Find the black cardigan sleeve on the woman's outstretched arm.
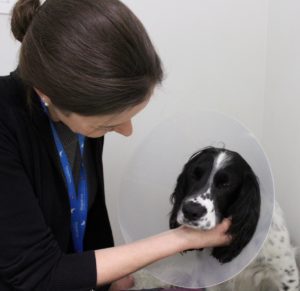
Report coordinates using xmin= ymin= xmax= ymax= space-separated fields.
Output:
xmin=0 ymin=110 xmax=96 ymax=291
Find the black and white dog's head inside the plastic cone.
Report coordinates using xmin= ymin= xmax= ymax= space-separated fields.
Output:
xmin=170 ymin=147 xmax=260 ymax=263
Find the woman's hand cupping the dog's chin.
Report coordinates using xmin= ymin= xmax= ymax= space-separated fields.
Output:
xmin=181 ymin=218 xmax=231 ymax=249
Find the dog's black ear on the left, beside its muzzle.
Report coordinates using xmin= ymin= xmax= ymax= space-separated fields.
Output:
xmin=169 ymin=166 xmax=187 ymax=228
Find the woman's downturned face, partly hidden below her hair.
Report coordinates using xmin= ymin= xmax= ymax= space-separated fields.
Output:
xmin=37 ymin=91 xmax=150 ymax=138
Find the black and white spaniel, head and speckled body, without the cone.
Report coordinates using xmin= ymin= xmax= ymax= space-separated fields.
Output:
xmin=170 ymin=147 xmax=299 ymax=291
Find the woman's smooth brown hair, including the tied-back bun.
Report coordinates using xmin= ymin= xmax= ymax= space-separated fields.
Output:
xmin=11 ymin=0 xmax=163 ymax=116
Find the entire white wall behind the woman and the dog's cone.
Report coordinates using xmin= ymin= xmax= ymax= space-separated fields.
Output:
xmin=0 ymin=0 xmax=300 ymax=244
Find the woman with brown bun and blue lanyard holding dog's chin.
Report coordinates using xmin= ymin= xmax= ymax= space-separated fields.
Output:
xmin=0 ymin=0 xmax=229 ymax=291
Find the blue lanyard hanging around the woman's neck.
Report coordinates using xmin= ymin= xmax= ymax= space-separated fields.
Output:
xmin=41 ymin=102 xmax=88 ymax=253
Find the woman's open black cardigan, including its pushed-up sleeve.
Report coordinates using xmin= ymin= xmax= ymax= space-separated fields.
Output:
xmin=0 ymin=72 xmax=113 ymax=291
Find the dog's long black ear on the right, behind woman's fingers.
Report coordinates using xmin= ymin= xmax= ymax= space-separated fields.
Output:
xmin=212 ymin=168 xmax=260 ymax=263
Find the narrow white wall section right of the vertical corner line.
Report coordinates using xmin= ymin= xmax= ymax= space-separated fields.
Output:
xmin=263 ymin=0 xmax=300 ymax=245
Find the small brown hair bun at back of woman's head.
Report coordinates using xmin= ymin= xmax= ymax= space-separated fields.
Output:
xmin=11 ymin=0 xmax=40 ymax=42
